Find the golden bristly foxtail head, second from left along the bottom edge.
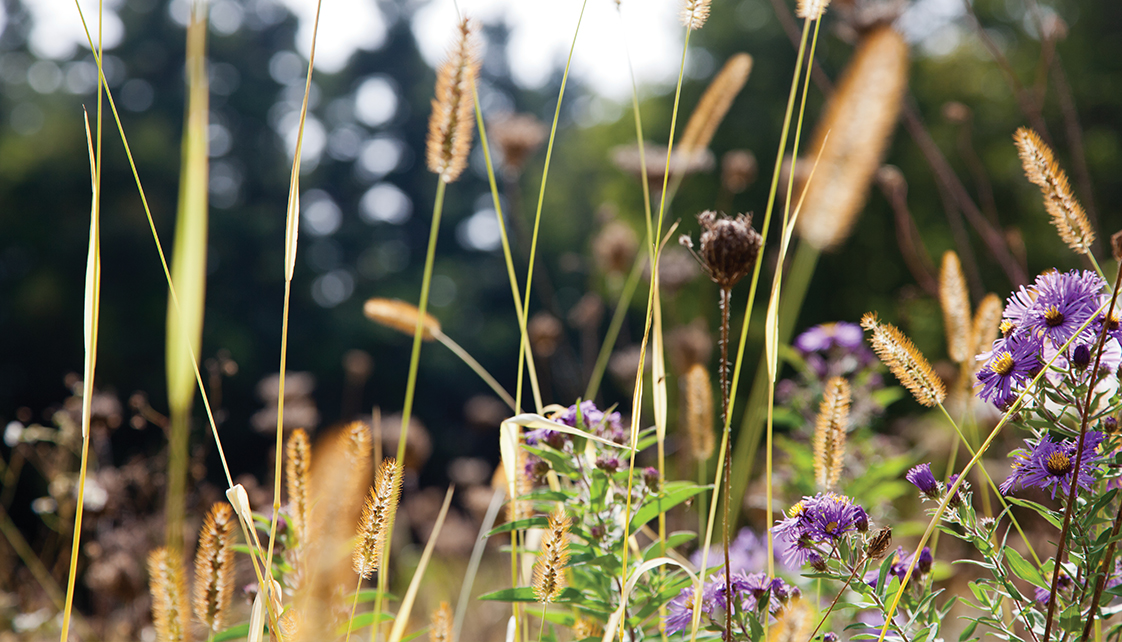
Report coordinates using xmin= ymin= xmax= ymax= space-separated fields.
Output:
xmin=194 ymin=502 xmax=238 ymax=633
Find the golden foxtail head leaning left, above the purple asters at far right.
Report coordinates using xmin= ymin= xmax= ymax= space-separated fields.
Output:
xmin=1013 ymin=127 xmax=1095 ymax=254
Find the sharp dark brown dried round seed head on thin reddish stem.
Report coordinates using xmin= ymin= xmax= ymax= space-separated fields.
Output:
xmin=679 ymin=210 xmax=763 ymax=290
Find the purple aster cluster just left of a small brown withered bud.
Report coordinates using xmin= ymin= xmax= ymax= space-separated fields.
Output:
xmin=772 ymin=493 xmax=868 ymax=568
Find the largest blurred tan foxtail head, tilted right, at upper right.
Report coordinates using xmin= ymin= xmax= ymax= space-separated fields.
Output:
xmin=794 ymin=26 xmax=908 ymax=250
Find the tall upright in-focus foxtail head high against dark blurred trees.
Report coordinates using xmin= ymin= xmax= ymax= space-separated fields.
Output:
xmin=426 ymin=18 xmax=479 ymax=183
